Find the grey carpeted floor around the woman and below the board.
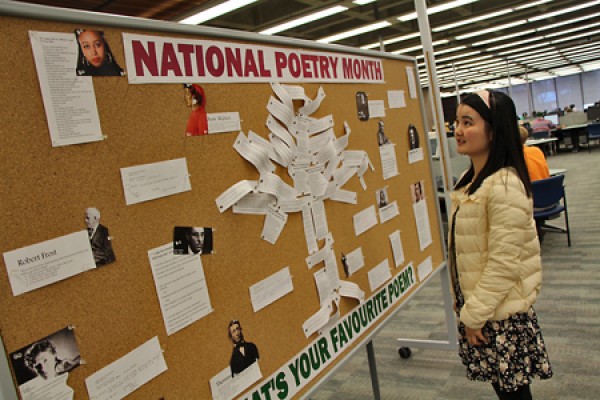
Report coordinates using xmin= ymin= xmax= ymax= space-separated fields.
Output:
xmin=310 ymin=146 xmax=600 ymax=400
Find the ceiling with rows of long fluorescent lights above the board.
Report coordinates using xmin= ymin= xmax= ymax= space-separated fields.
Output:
xmin=11 ymin=0 xmax=600 ymax=91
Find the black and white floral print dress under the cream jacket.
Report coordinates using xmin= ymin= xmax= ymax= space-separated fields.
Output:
xmin=449 ymin=209 xmax=552 ymax=392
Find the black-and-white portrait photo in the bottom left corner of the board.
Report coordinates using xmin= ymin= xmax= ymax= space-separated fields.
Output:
xmin=10 ymin=326 xmax=81 ymax=386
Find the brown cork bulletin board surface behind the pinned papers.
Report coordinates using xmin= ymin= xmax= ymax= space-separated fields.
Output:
xmin=0 ymin=3 xmax=444 ymax=400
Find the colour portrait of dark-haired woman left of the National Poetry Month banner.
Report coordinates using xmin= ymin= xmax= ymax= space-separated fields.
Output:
xmin=75 ymin=29 xmax=125 ymax=76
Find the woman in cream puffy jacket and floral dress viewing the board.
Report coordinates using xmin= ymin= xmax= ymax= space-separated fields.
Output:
xmin=448 ymin=91 xmax=552 ymax=399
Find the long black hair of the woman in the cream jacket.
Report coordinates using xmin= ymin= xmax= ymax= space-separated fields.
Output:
xmin=455 ymin=91 xmax=531 ymax=197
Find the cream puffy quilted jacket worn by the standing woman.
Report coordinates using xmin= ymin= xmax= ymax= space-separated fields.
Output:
xmin=449 ymin=168 xmax=542 ymax=329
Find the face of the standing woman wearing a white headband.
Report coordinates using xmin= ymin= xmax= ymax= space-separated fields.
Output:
xmin=454 ymin=104 xmax=492 ymax=157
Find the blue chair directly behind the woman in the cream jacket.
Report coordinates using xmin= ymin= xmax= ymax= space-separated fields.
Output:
xmin=532 ymin=175 xmax=571 ymax=247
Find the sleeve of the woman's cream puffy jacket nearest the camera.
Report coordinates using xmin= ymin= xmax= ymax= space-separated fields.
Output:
xmin=460 ymin=171 xmax=532 ymax=329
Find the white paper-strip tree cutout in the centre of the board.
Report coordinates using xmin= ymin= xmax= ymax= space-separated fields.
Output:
xmin=216 ymin=83 xmax=373 ymax=336
